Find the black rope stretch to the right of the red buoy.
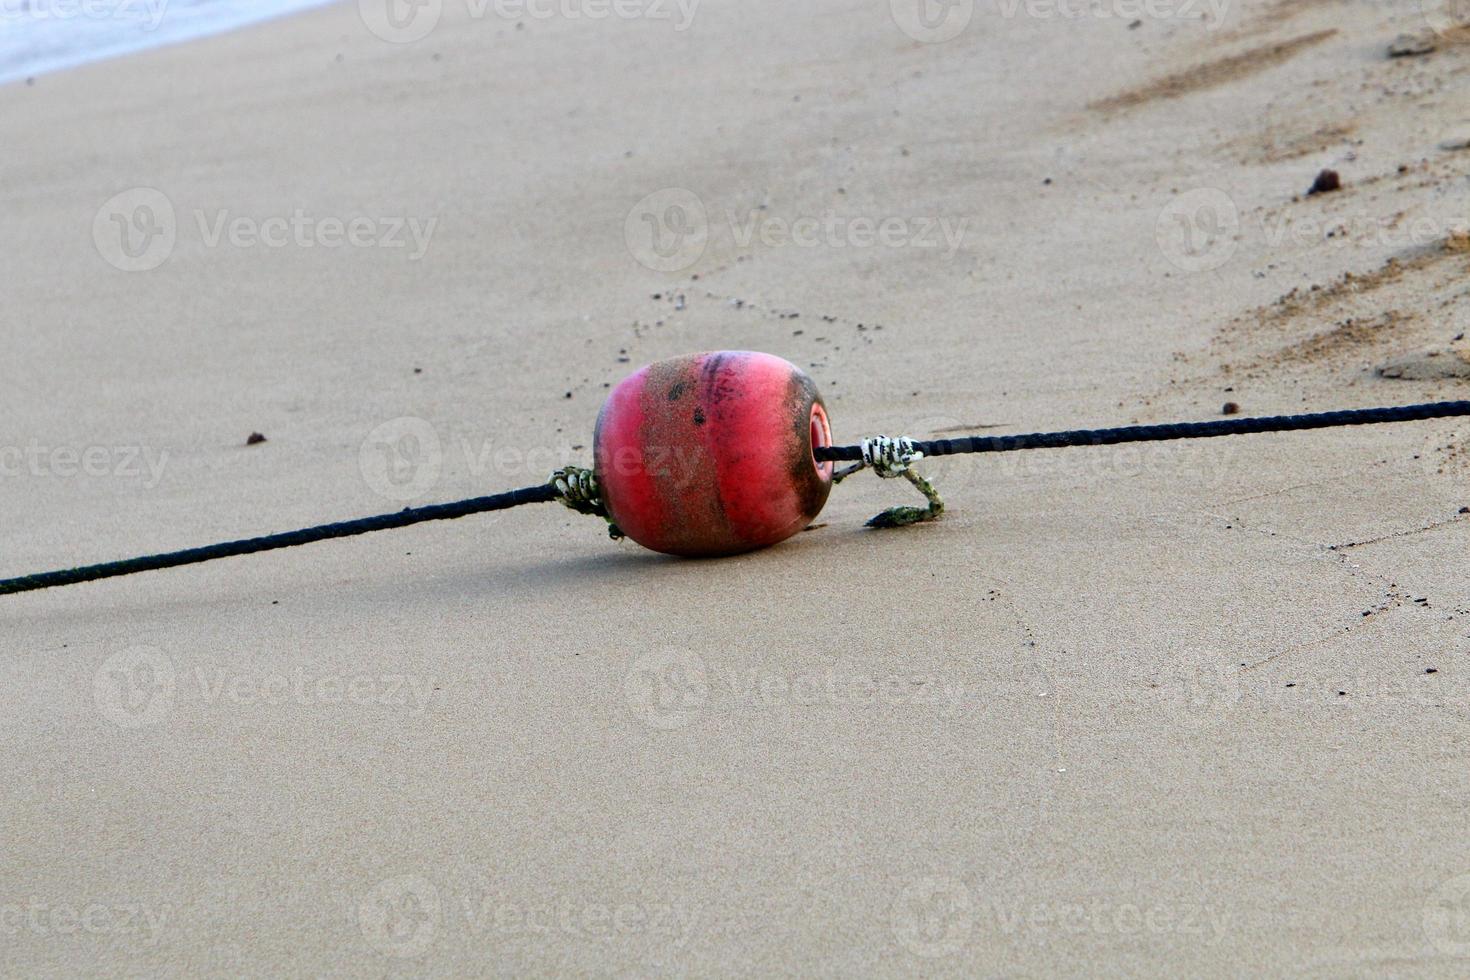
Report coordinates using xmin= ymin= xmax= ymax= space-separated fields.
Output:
xmin=816 ymin=401 xmax=1470 ymax=461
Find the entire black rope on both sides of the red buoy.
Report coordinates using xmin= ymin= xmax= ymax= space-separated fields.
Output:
xmin=0 ymin=401 xmax=1470 ymax=595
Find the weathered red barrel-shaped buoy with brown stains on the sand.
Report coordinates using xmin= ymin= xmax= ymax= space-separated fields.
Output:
xmin=592 ymin=351 xmax=832 ymax=557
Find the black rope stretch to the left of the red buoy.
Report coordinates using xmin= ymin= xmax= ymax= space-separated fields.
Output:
xmin=0 ymin=483 xmax=557 ymax=595
